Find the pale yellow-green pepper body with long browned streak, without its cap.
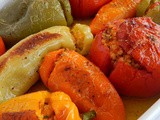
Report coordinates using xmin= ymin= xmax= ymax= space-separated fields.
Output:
xmin=0 ymin=26 xmax=75 ymax=102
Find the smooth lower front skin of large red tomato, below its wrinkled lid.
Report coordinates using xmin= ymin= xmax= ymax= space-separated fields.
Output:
xmin=109 ymin=61 xmax=160 ymax=97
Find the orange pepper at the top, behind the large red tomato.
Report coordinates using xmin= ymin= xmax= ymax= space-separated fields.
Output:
xmin=90 ymin=0 xmax=141 ymax=35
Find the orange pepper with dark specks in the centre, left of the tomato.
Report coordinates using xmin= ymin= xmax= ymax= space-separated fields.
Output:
xmin=39 ymin=49 xmax=125 ymax=120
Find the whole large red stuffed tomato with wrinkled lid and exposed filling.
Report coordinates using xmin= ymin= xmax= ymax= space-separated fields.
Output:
xmin=90 ymin=17 xmax=160 ymax=97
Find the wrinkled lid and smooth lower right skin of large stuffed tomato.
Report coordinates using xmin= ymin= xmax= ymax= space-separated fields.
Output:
xmin=109 ymin=17 xmax=160 ymax=97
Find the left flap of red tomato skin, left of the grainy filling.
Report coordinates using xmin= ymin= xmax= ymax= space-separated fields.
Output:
xmin=89 ymin=31 xmax=112 ymax=75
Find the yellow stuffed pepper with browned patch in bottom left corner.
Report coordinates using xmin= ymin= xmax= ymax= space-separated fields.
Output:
xmin=0 ymin=91 xmax=81 ymax=120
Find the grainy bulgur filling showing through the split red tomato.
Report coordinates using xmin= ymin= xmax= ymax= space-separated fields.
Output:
xmin=102 ymin=27 xmax=142 ymax=69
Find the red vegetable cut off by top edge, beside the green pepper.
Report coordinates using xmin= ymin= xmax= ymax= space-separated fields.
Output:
xmin=70 ymin=0 xmax=111 ymax=18
